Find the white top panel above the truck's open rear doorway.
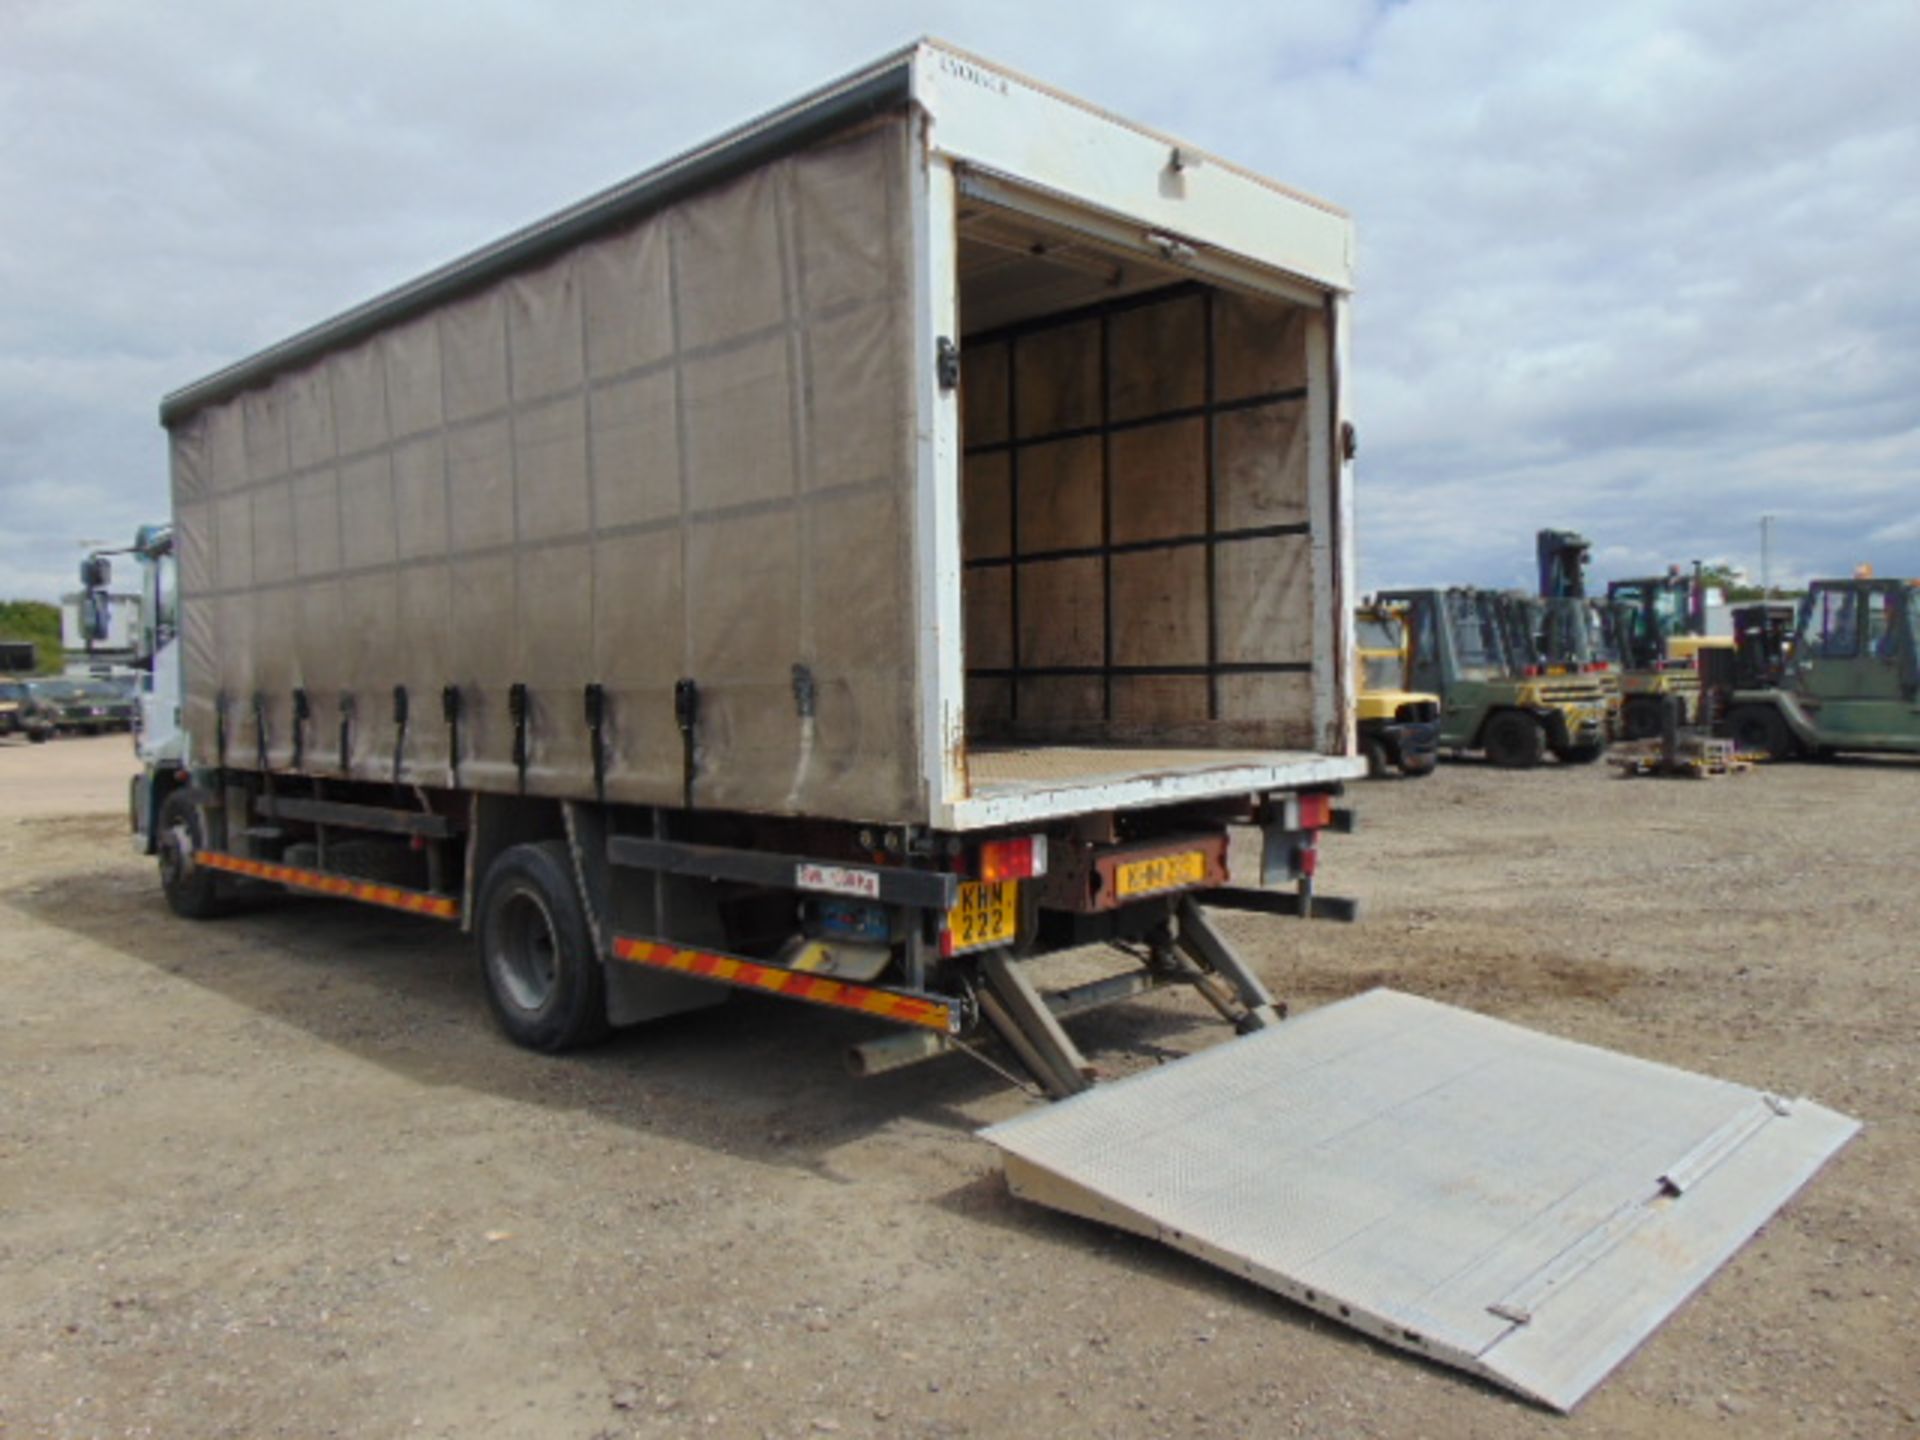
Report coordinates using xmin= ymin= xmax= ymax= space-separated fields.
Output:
xmin=912 ymin=40 xmax=1354 ymax=292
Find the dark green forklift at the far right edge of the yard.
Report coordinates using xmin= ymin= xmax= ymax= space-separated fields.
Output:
xmin=1726 ymin=578 xmax=1920 ymax=760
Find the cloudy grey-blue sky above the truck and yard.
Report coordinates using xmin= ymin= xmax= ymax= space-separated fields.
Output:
xmin=0 ymin=0 xmax=1920 ymax=599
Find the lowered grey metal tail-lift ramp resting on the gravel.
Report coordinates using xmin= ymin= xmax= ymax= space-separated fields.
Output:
xmin=983 ymin=991 xmax=1859 ymax=1409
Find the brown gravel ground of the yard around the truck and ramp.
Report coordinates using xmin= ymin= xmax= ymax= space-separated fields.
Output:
xmin=0 ymin=737 xmax=1920 ymax=1440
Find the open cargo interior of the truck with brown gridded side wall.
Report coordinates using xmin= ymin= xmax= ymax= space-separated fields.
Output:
xmin=956 ymin=194 xmax=1338 ymax=814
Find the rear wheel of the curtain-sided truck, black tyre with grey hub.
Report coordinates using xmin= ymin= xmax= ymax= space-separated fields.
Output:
xmin=474 ymin=841 xmax=609 ymax=1054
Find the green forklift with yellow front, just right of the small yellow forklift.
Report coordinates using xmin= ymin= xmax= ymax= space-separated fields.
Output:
xmin=1377 ymin=586 xmax=1607 ymax=770
